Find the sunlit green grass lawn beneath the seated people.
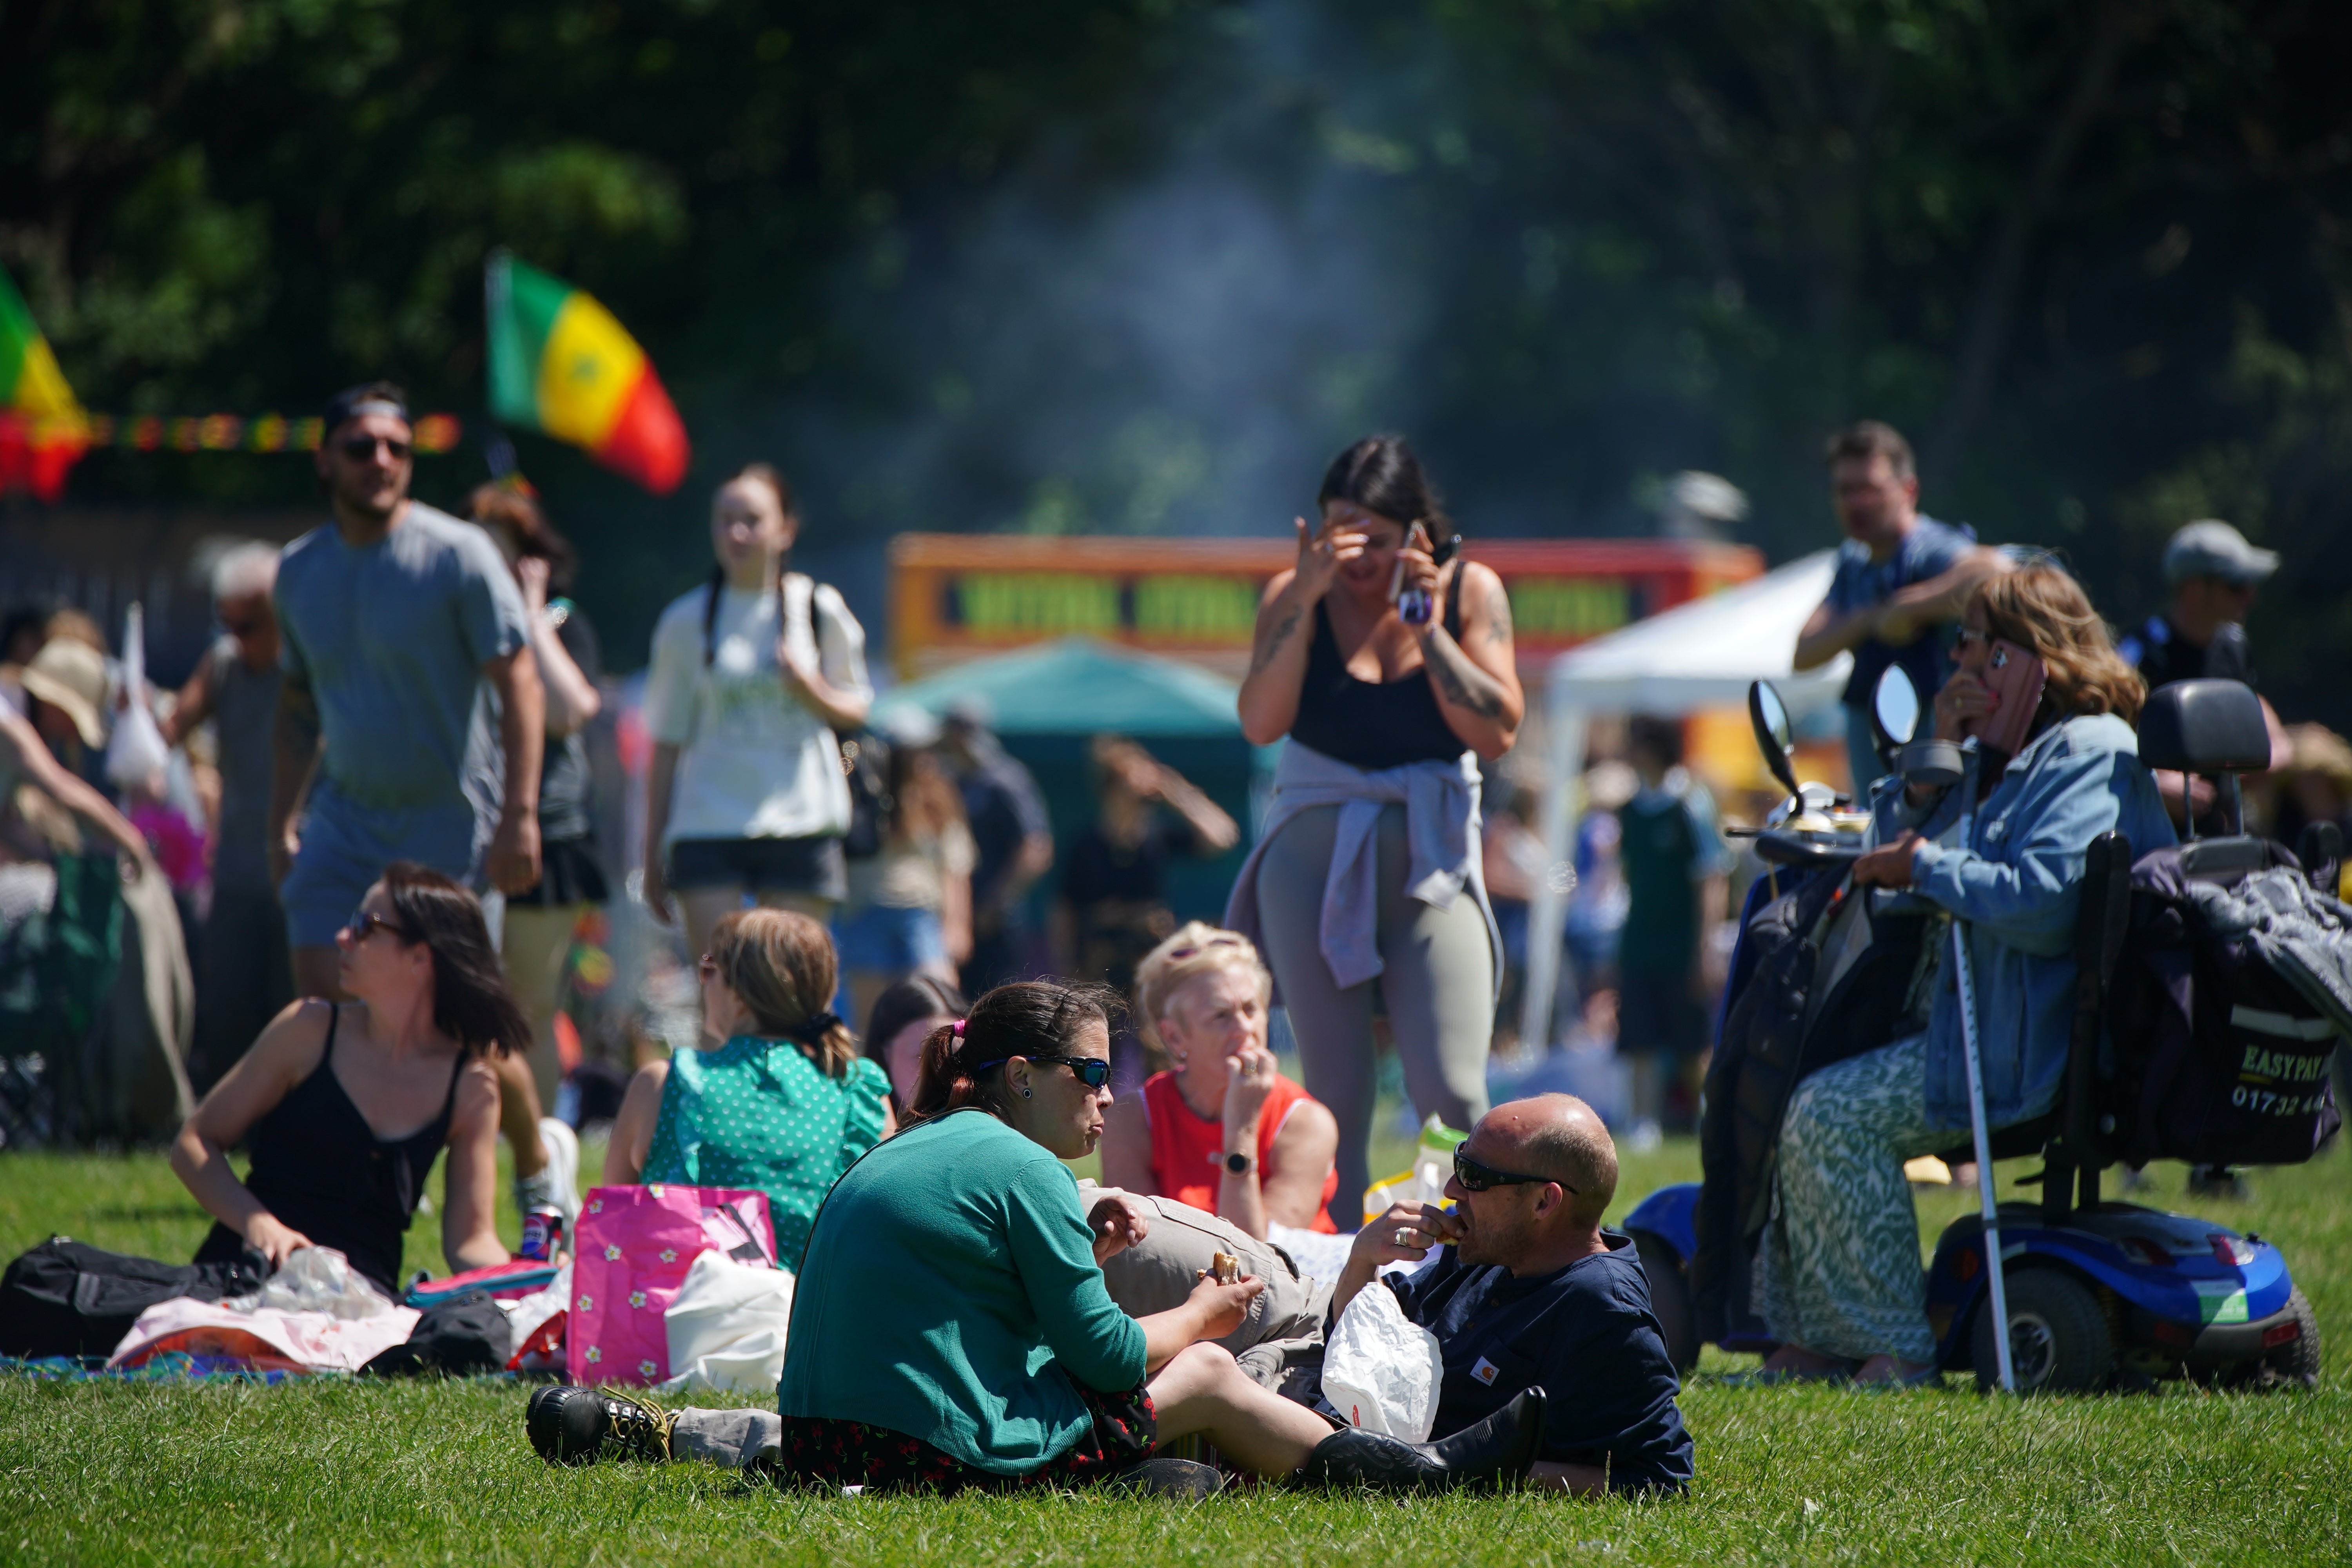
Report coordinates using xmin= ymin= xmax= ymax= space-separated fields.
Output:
xmin=0 ymin=1143 xmax=2352 ymax=1568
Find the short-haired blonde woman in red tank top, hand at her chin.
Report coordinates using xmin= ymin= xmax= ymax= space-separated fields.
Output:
xmin=1101 ymin=919 xmax=1338 ymax=1241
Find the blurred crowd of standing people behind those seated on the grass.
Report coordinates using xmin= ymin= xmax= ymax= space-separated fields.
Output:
xmin=0 ymin=386 xmax=2324 ymax=1189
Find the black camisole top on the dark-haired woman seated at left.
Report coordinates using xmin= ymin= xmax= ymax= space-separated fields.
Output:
xmin=195 ymin=1004 xmax=466 ymax=1300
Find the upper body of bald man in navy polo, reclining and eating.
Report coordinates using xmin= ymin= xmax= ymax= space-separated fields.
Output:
xmin=1331 ymin=1096 xmax=1691 ymax=1493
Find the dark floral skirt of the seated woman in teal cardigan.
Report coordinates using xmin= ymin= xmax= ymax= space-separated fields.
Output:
xmin=781 ymin=1380 xmax=1160 ymax=1493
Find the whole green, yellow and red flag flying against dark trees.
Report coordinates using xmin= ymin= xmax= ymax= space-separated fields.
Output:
xmin=485 ymin=249 xmax=687 ymax=496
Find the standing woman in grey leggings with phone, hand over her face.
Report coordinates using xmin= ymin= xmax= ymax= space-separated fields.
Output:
xmin=1225 ymin=435 xmax=1524 ymax=1232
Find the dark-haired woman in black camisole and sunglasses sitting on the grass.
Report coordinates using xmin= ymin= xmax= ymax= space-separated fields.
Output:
xmin=172 ymin=860 xmax=532 ymax=1295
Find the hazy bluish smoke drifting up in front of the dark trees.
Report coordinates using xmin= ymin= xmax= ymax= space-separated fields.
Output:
xmin=786 ymin=2 xmax=1430 ymax=557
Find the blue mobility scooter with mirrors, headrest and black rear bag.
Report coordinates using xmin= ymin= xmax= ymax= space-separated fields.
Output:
xmin=1623 ymin=670 xmax=2345 ymax=1392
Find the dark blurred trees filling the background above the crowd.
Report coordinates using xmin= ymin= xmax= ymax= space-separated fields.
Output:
xmin=0 ymin=0 xmax=2352 ymax=726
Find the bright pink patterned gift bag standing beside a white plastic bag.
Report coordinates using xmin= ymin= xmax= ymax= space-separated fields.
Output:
xmin=564 ymin=1182 xmax=776 ymax=1385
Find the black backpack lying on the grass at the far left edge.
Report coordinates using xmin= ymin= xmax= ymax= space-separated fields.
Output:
xmin=0 ymin=1236 xmax=268 ymax=1359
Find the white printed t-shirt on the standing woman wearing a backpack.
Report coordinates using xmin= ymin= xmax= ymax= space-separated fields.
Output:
xmin=644 ymin=571 xmax=870 ymax=846
